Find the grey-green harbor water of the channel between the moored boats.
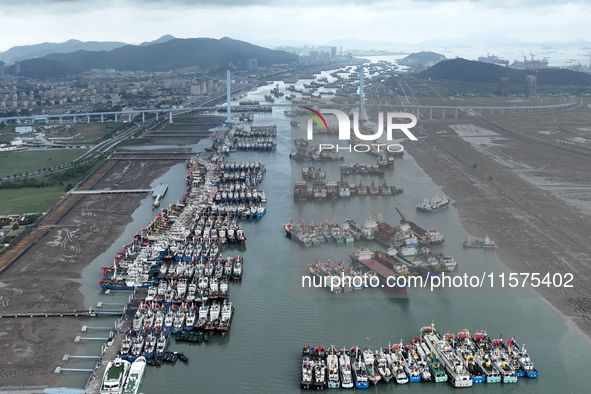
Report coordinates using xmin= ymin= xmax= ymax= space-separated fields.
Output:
xmin=65 ymin=73 xmax=591 ymax=394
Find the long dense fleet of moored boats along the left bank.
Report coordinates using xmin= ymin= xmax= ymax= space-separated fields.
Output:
xmin=99 ymin=139 xmax=266 ymax=388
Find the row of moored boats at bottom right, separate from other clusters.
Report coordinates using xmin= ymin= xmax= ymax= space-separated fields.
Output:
xmin=300 ymin=324 xmax=539 ymax=390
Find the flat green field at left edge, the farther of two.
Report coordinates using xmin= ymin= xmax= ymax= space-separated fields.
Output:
xmin=0 ymin=149 xmax=86 ymax=178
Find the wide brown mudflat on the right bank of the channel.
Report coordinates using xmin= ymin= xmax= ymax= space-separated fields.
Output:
xmin=405 ymin=120 xmax=591 ymax=335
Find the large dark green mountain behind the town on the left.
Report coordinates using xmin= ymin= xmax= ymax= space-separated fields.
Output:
xmin=7 ymin=37 xmax=298 ymax=78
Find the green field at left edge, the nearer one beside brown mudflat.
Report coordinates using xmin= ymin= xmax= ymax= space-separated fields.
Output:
xmin=0 ymin=182 xmax=69 ymax=215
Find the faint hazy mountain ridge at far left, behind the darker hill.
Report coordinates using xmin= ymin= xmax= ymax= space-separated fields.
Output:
xmin=0 ymin=40 xmax=127 ymax=63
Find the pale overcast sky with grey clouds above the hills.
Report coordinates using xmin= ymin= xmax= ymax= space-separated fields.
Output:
xmin=0 ymin=0 xmax=591 ymax=51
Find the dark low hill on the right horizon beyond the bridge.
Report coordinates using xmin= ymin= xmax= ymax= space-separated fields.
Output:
xmin=416 ymin=59 xmax=591 ymax=85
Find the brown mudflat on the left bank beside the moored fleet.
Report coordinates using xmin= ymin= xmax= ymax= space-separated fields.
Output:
xmin=0 ymin=159 xmax=184 ymax=387
